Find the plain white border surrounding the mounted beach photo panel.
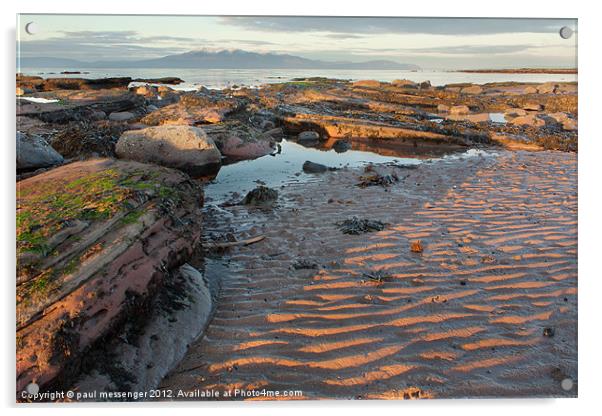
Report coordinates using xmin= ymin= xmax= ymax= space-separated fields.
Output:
xmin=0 ymin=0 xmax=602 ymax=416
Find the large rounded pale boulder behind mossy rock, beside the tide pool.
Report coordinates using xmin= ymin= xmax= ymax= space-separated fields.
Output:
xmin=115 ymin=126 xmax=221 ymax=176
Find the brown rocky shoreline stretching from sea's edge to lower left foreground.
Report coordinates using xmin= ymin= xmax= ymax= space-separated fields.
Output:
xmin=16 ymin=74 xmax=578 ymax=396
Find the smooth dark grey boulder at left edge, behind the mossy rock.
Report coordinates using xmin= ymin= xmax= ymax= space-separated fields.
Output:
xmin=17 ymin=132 xmax=64 ymax=171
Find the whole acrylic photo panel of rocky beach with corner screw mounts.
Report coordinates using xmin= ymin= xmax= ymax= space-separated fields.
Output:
xmin=16 ymin=14 xmax=578 ymax=402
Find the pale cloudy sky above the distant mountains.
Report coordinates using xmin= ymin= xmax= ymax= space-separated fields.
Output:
xmin=17 ymin=15 xmax=577 ymax=69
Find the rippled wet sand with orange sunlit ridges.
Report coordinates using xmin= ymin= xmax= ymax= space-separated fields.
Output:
xmin=161 ymin=151 xmax=577 ymax=400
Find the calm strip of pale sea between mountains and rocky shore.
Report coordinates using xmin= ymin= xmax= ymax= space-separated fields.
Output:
xmin=21 ymin=68 xmax=577 ymax=90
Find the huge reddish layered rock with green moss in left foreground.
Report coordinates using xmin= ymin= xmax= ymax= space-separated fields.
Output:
xmin=16 ymin=159 xmax=202 ymax=391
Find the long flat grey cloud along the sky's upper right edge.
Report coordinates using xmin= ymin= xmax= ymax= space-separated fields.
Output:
xmin=220 ymin=16 xmax=576 ymax=35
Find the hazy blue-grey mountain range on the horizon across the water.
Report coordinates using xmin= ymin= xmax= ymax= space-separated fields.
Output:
xmin=20 ymin=50 xmax=420 ymax=70
